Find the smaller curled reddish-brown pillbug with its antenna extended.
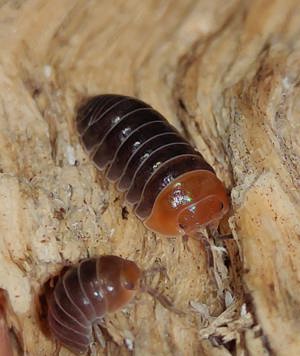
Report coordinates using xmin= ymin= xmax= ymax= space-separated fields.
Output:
xmin=47 ymin=255 xmax=176 ymax=354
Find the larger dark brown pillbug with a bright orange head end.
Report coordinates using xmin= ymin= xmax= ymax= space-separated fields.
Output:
xmin=76 ymin=94 xmax=229 ymax=236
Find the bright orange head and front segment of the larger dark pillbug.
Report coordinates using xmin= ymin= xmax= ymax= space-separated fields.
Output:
xmin=144 ymin=170 xmax=229 ymax=236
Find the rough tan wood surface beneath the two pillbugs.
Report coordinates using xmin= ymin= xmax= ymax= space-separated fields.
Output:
xmin=0 ymin=0 xmax=300 ymax=356
